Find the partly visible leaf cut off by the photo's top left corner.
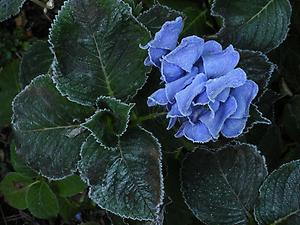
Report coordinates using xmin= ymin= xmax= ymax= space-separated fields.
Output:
xmin=0 ymin=0 xmax=26 ymax=22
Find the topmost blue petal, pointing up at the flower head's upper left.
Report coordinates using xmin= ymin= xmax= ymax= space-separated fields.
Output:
xmin=144 ymin=17 xmax=183 ymax=50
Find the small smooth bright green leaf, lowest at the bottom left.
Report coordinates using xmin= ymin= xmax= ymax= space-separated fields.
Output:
xmin=26 ymin=181 xmax=59 ymax=219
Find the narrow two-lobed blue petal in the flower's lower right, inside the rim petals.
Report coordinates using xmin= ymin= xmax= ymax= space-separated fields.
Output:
xmin=200 ymin=96 xmax=237 ymax=139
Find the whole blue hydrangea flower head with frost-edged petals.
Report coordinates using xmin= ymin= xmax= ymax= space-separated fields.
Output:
xmin=145 ymin=17 xmax=258 ymax=143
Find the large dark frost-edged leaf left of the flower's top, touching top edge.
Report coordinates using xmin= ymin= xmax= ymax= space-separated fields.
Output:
xmin=50 ymin=0 xmax=150 ymax=105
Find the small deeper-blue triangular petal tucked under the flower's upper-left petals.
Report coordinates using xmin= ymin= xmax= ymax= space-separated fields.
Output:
xmin=161 ymin=60 xmax=185 ymax=83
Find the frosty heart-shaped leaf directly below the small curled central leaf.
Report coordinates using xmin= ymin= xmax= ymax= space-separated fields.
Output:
xmin=78 ymin=128 xmax=164 ymax=220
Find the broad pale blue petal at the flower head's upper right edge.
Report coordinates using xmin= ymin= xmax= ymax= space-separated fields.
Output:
xmin=202 ymin=45 xmax=240 ymax=78
